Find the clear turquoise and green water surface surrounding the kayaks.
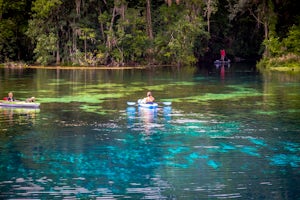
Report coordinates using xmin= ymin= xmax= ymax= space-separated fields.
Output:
xmin=0 ymin=65 xmax=300 ymax=199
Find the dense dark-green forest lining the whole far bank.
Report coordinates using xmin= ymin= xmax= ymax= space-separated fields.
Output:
xmin=0 ymin=0 xmax=300 ymax=66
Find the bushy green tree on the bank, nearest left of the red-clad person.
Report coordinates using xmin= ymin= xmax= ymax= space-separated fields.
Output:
xmin=155 ymin=5 xmax=206 ymax=64
